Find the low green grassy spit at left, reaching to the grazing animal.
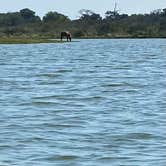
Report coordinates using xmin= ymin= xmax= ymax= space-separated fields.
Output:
xmin=0 ymin=38 xmax=65 ymax=44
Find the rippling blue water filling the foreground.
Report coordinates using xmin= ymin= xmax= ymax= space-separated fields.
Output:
xmin=0 ymin=39 xmax=166 ymax=166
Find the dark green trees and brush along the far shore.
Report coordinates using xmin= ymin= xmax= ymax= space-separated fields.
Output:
xmin=0 ymin=9 xmax=166 ymax=38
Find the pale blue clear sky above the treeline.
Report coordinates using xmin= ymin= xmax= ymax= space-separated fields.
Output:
xmin=0 ymin=0 xmax=166 ymax=19
